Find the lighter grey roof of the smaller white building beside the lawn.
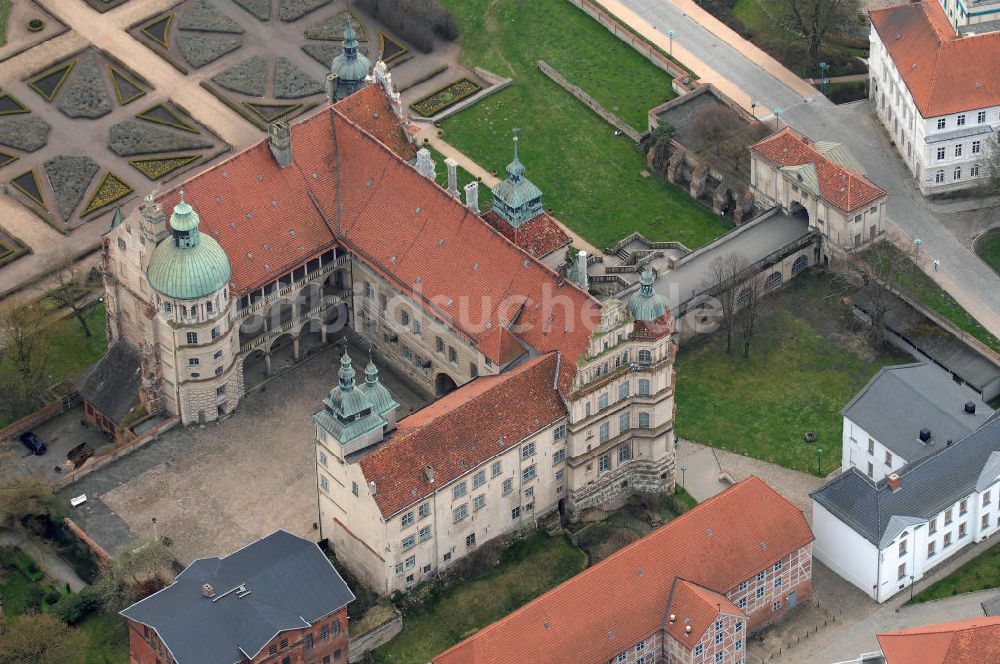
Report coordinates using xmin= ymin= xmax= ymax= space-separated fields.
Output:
xmin=841 ymin=363 xmax=993 ymax=462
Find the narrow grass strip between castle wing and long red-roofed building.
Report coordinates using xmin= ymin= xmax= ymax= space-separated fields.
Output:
xmin=372 ymin=533 xmax=586 ymax=664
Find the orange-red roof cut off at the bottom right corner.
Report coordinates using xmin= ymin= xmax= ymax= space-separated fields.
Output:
xmin=878 ymin=617 xmax=1000 ymax=664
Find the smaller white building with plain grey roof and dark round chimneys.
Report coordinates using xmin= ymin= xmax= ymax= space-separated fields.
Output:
xmin=840 ymin=363 xmax=993 ymax=482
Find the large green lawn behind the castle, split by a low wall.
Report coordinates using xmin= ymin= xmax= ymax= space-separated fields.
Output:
xmin=442 ymin=0 xmax=729 ymax=248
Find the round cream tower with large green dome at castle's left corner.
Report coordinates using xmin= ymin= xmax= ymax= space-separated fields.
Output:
xmin=146 ymin=191 xmax=243 ymax=424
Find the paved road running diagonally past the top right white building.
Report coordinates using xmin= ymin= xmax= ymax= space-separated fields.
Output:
xmin=620 ymin=0 xmax=1000 ymax=335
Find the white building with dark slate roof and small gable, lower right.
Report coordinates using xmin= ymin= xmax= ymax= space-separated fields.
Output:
xmin=812 ymin=419 xmax=1000 ymax=602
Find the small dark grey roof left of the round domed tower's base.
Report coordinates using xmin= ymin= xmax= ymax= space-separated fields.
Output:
xmin=80 ymin=338 xmax=142 ymax=424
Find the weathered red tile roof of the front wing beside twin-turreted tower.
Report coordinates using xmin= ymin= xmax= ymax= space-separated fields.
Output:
xmin=359 ymin=353 xmax=566 ymax=518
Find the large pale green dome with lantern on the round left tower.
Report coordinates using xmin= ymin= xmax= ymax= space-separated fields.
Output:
xmin=146 ymin=193 xmax=232 ymax=300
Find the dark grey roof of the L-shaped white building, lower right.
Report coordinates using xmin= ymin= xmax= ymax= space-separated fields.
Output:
xmin=810 ymin=420 xmax=1000 ymax=549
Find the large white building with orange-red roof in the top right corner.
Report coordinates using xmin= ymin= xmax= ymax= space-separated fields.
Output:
xmin=869 ymin=0 xmax=1000 ymax=194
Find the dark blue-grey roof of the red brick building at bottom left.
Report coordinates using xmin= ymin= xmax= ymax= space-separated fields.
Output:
xmin=121 ymin=530 xmax=354 ymax=664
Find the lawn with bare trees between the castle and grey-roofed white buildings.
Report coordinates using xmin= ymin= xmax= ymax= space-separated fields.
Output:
xmin=677 ymin=273 xmax=912 ymax=475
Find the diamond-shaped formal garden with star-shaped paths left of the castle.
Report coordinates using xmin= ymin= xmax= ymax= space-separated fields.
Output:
xmin=0 ymin=47 xmax=229 ymax=231
